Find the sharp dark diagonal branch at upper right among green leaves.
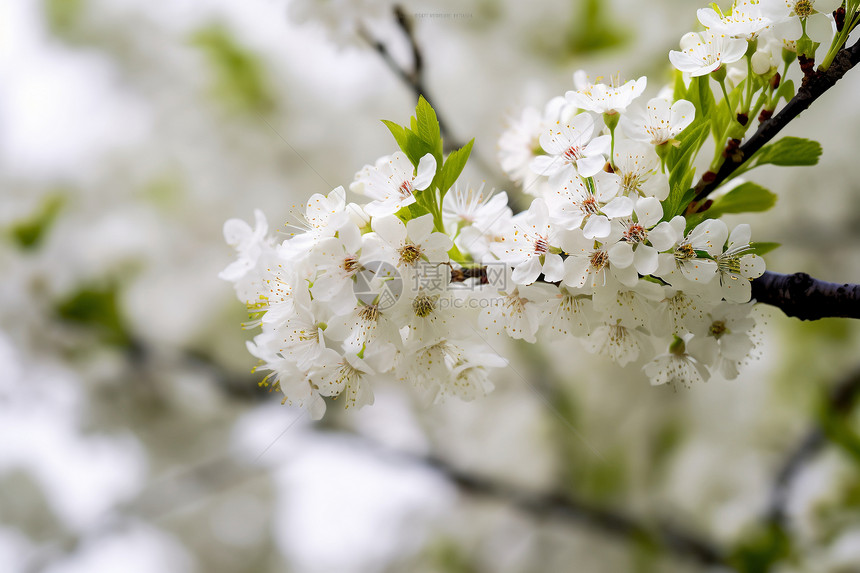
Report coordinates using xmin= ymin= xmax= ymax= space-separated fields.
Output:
xmin=691 ymin=35 xmax=860 ymax=207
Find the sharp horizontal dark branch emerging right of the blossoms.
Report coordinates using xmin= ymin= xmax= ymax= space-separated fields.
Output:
xmin=752 ymin=271 xmax=860 ymax=320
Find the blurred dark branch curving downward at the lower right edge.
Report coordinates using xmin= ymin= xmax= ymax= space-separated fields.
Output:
xmin=766 ymin=369 xmax=860 ymax=528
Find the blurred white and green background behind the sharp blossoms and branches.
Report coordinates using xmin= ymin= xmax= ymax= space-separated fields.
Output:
xmin=0 ymin=0 xmax=860 ymax=573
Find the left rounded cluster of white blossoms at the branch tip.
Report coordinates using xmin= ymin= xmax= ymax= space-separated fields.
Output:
xmin=221 ymin=170 xmax=506 ymax=418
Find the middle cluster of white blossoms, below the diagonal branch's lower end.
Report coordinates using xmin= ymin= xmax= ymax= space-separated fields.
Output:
xmin=490 ymin=66 xmax=764 ymax=384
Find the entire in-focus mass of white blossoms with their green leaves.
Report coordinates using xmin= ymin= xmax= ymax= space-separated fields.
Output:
xmin=221 ymin=0 xmax=857 ymax=418
